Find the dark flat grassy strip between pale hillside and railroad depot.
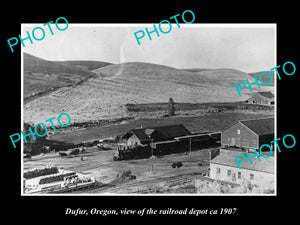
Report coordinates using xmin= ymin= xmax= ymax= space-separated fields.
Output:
xmin=48 ymin=110 xmax=274 ymax=144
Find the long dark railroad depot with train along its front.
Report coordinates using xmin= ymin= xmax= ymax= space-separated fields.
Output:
xmin=113 ymin=124 xmax=221 ymax=161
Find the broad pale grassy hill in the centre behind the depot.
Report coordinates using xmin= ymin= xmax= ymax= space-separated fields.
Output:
xmin=24 ymin=62 xmax=272 ymax=125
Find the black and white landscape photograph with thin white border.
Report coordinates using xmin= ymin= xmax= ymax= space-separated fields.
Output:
xmin=20 ymin=23 xmax=276 ymax=196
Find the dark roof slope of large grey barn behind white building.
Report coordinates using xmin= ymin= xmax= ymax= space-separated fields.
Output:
xmin=239 ymin=117 xmax=274 ymax=135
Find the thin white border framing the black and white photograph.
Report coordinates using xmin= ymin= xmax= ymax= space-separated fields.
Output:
xmin=20 ymin=23 xmax=277 ymax=196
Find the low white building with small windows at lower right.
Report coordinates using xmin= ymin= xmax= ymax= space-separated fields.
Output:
xmin=209 ymin=149 xmax=275 ymax=188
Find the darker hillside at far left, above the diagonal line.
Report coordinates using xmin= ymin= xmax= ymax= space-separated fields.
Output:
xmin=23 ymin=53 xmax=108 ymax=101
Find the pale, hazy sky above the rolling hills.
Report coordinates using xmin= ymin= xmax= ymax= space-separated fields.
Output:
xmin=21 ymin=23 xmax=276 ymax=72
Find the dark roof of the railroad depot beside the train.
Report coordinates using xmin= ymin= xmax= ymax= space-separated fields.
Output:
xmin=122 ymin=124 xmax=191 ymax=141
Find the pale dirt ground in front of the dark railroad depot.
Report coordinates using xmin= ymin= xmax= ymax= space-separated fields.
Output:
xmin=24 ymin=147 xmax=216 ymax=194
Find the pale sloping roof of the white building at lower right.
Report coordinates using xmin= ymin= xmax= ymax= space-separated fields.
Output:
xmin=210 ymin=149 xmax=275 ymax=173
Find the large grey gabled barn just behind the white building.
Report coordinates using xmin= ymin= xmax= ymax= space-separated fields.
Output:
xmin=221 ymin=117 xmax=274 ymax=150
